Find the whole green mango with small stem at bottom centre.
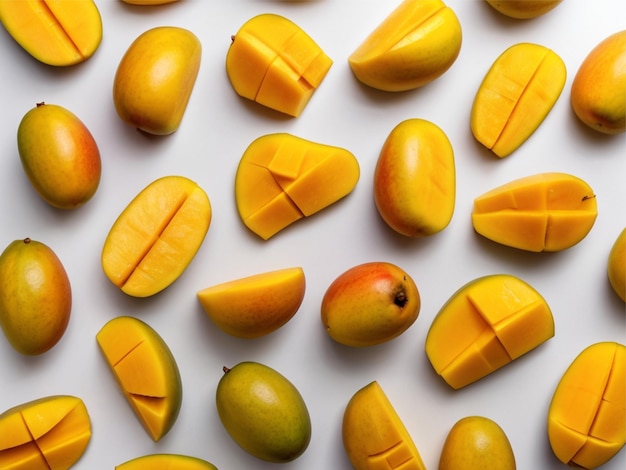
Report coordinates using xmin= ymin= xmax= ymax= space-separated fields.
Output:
xmin=215 ymin=362 xmax=311 ymax=463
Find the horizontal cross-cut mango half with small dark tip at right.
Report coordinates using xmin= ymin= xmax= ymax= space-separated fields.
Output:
xmin=472 ymin=173 xmax=598 ymax=252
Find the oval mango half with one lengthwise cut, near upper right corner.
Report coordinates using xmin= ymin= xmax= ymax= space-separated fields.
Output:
xmin=470 ymin=43 xmax=567 ymax=158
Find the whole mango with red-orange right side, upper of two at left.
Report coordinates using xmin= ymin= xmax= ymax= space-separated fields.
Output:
xmin=17 ymin=102 xmax=102 ymax=209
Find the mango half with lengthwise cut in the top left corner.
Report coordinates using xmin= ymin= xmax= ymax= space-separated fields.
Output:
xmin=0 ymin=0 xmax=102 ymax=66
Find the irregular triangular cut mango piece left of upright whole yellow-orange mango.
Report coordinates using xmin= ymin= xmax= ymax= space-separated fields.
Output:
xmin=235 ymin=133 xmax=360 ymax=240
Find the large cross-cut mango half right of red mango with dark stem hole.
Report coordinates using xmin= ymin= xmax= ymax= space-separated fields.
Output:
xmin=426 ymin=274 xmax=554 ymax=389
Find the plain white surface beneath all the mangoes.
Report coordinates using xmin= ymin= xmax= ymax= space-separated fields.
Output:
xmin=0 ymin=0 xmax=626 ymax=470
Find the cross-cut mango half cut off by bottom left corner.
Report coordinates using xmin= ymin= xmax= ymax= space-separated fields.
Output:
xmin=0 ymin=395 xmax=91 ymax=470
